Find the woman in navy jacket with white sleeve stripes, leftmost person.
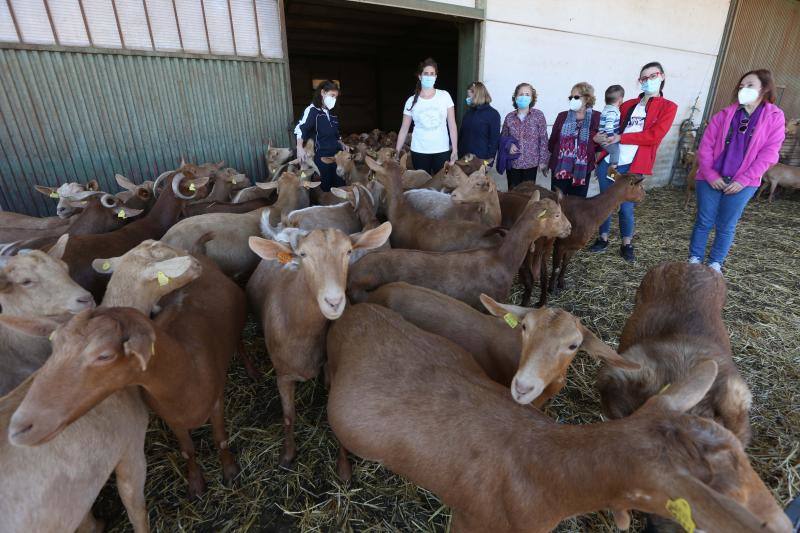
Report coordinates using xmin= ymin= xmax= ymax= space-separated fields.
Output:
xmin=294 ymin=80 xmax=349 ymax=192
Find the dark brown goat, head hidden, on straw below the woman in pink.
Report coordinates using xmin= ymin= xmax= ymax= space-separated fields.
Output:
xmin=598 ymin=263 xmax=751 ymax=446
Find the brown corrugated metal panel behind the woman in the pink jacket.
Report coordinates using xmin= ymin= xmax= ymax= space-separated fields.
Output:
xmin=711 ymin=0 xmax=800 ymax=118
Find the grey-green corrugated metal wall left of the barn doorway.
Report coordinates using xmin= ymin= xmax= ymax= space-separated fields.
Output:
xmin=0 ymin=49 xmax=292 ymax=215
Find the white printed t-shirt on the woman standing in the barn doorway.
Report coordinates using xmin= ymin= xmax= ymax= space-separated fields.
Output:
xmin=403 ymin=89 xmax=454 ymax=154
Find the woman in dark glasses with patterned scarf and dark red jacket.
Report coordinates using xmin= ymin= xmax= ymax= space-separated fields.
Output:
xmin=550 ymin=82 xmax=600 ymax=198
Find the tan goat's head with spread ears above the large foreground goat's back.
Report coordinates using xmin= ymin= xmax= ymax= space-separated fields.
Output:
xmin=481 ymin=294 xmax=640 ymax=407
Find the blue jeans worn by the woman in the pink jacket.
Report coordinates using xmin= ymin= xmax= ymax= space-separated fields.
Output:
xmin=689 ymin=180 xmax=758 ymax=265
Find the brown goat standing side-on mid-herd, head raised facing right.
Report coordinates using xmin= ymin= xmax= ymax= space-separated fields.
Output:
xmin=348 ymin=194 xmax=570 ymax=309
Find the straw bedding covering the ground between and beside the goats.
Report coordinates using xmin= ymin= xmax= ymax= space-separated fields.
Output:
xmin=95 ymin=189 xmax=800 ymax=532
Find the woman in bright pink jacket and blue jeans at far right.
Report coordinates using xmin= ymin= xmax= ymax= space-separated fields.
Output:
xmin=689 ymin=69 xmax=785 ymax=272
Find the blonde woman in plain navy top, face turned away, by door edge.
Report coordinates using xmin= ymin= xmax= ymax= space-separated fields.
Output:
xmin=458 ymin=81 xmax=500 ymax=161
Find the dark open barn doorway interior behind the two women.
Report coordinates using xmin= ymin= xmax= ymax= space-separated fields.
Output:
xmin=285 ymin=0 xmax=459 ymax=134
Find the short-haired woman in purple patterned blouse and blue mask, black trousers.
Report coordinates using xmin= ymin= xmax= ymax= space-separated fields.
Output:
xmin=500 ymin=83 xmax=550 ymax=191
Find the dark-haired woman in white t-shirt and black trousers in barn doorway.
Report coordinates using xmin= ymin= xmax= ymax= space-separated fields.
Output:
xmin=396 ymin=58 xmax=458 ymax=175
